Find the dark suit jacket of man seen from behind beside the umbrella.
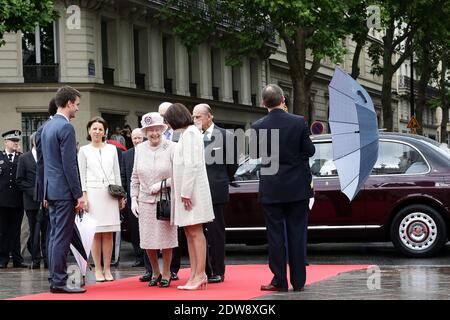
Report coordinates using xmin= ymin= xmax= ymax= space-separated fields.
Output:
xmin=252 ymin=109 xmax=315 ymax=203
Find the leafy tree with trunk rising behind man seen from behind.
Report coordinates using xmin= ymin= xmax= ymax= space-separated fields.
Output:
xmin=161 ymin=0 xmax=348 ymax=120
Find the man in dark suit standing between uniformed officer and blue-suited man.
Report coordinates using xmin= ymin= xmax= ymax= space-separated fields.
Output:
xmin=16 ymin=133 xmax=47 ymax=269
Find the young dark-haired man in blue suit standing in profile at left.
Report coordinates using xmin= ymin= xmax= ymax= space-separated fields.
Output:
xmin=41 ymin=86 xmax=86 ymax=293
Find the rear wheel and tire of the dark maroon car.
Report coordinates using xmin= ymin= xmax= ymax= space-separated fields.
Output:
xmin=391 ymin=204 xmax=447 ymax=258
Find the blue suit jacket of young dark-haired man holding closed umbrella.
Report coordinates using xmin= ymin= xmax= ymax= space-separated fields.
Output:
xmin=41 ymin=114 xmax=83 ymax=200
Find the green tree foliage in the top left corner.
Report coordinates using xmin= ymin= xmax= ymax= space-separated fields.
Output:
xmin=0 ymin=0 xmax=54 ymax=46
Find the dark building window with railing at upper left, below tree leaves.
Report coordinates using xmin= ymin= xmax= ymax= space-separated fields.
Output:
xmin=22 ymin=22 xmax=59 ymax=83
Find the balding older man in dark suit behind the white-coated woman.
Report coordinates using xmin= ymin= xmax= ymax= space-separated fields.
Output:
xmin=192 ymin=103 xmax=238 ymax=283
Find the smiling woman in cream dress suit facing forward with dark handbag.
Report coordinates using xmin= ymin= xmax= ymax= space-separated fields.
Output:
xmin=78 ymin=117 xmax=124 ymax=282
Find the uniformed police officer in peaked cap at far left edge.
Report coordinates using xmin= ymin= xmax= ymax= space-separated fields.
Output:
xmin=0 ymin=130 xmax=27 ymax=268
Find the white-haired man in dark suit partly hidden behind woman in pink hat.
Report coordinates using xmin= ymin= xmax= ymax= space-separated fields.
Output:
xmin=120 ymin=128 xmax=143 ymax=268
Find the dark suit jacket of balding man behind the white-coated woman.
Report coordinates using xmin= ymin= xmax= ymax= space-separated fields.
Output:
xmin=205 ymin=125 xmax=238 ymax=204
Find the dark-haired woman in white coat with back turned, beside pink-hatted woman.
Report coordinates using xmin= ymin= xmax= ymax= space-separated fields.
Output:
xmin=164 ymin=103 xmax=214 ymax=290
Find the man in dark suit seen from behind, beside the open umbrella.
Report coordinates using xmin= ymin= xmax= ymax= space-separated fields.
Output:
xmin=250 ymin=84 xmax=315 ymax=291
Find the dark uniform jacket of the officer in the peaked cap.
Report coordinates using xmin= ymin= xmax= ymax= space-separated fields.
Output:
xmin=0 ymin=151 xmax=23 ymax=208
